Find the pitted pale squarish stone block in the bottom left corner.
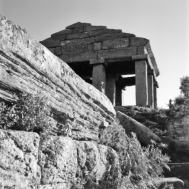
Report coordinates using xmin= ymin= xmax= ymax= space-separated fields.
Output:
xmin=0 ymin=130 xmax=41 ymax=189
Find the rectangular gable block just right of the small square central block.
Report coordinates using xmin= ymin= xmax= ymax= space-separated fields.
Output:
xmin=102 ymin=38 xmax=129 ymax=49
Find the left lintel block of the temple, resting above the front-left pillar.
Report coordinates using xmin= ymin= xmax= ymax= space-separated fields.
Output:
xmin=60 ymin=51 xmax=97 ymax=63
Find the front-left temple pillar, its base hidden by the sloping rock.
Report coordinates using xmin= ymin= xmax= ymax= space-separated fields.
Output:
xmin=92 ymin=64 xmax=106 ymax=94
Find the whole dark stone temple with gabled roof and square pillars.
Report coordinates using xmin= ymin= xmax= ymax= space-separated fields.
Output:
xmin=41 ymin=22 xmax=160 ymax=108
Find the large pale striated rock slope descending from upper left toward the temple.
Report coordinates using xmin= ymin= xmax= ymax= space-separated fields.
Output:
xmin=0 ymin=15 xmax=115 ymax=140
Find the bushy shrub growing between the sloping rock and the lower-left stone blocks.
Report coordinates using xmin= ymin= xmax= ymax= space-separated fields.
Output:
xmin=0 ymin=93 xmax=52 ymax=134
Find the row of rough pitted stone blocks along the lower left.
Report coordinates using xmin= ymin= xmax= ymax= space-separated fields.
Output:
xmin=0 ymin=130 xmax=120 ymax=189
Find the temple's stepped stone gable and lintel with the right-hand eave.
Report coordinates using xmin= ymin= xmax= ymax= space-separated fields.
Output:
xmin=41 ymin=22 xmax=160 ymax=77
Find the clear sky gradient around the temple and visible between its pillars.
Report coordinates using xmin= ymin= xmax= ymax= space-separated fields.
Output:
xmin=0 ymin=0 xmax=189 ymax=108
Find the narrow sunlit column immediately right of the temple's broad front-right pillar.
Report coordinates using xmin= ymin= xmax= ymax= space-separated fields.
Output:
xmin=148 ymin=74 xmax=154 ymax=108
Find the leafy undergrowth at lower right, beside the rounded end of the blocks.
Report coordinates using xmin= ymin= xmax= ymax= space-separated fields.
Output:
xmin=100 ymin=124 xmax=169 ymax=189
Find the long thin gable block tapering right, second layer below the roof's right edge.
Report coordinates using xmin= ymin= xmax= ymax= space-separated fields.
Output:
xmin=95 ymin=33 xmax=134 ymax=42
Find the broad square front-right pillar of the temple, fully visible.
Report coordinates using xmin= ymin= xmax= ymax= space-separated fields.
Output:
xmin=135 ymin=60 xmax=148 ymax=106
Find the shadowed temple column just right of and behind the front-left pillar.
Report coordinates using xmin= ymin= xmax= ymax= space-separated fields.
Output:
xmin=106 ymin=77 xmax=116 ymax=106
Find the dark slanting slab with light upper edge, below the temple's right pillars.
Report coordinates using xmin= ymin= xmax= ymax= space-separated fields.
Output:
xmin=117 ymin=111 xmax=161 ymax=145
